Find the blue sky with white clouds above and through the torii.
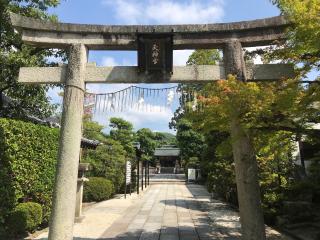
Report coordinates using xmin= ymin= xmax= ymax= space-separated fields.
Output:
xmin=48 ymin=0 xmax=280 ymax=133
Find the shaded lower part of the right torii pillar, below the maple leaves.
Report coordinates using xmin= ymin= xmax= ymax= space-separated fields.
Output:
xmin=231 ymin=116 xmax=265 ymax=240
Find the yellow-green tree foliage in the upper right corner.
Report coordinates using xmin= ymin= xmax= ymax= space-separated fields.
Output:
xmin=252 ymin=0 xmax=320 ymax=84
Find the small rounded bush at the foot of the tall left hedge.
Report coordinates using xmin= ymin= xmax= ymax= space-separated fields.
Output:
xmin=8 ymin=202 xmax=42 ymax=233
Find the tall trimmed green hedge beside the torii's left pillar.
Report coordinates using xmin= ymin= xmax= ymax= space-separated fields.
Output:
xmin=0 ymin=118 xmax=59 ymax=226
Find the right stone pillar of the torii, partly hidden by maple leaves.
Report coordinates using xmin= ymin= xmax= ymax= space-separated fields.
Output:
xmin=224 ymin=40 xmax=266 ymax=240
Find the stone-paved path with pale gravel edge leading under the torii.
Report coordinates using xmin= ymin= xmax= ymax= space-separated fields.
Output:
xmin=34 ymin=184 xmax=286 ymax=240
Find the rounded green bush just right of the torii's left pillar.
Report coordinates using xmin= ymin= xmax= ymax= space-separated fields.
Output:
xmin=83 ymin=177 xmax=114 ymax=202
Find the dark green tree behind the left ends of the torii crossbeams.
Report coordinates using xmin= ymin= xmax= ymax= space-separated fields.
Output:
xmin=0 ymin=0 xmax=60 ymax=118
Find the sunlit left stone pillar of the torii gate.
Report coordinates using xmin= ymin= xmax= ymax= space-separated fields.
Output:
xmin=49 ymin=44 xmax=87 ymax=240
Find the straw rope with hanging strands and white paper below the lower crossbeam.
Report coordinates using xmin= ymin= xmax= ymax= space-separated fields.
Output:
xmin=84 ymin=86 xmax=201 ymax=115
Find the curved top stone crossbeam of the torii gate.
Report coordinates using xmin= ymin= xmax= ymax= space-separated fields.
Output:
xmin=10 ymin=13 xmax=289 ymax=50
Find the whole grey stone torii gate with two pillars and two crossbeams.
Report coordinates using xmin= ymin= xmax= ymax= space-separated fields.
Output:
xmin=11 ymin=14 xmax=293 ymax=240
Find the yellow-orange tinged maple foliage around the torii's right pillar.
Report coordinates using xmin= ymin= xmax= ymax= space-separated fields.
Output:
xmin=185 ymin=71 xmax=319 ymax=223
